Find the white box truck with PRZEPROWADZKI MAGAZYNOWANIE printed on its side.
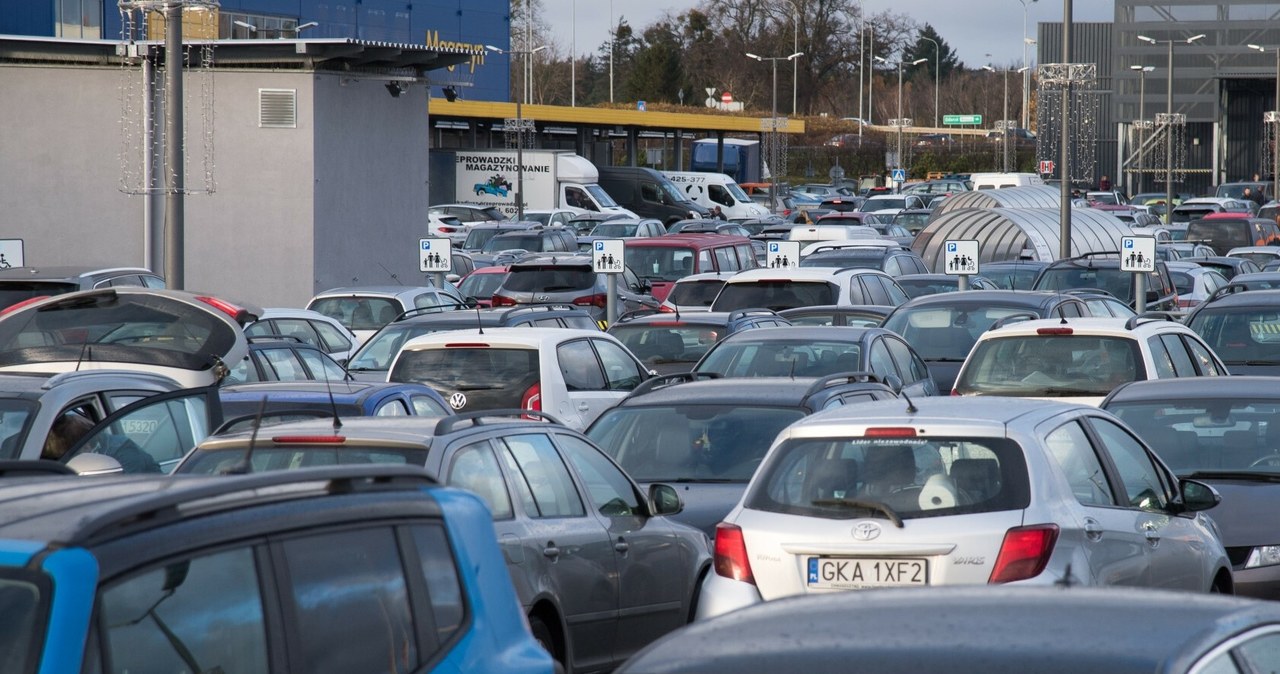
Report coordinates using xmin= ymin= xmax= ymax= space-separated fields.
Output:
xmin=430 ymin=150 xmax=635 ymax=217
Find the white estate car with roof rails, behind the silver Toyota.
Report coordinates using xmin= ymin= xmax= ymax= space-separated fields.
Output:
xmin=951 ymin=315 xmax=1228 ymax=405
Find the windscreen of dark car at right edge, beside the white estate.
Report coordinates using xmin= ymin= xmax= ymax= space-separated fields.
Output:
xmin=1188 ymin=304 xmax=1280 ymax=365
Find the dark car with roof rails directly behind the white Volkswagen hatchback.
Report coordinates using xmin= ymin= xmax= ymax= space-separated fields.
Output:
xmin=347 ymin=304 xmax=599 ymax=381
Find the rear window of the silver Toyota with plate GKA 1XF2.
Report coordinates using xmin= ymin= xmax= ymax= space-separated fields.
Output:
xmin=744 ymin=436 xmax=1030 ymax=519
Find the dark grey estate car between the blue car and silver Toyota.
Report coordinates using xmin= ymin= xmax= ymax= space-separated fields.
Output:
xmin=175 ymin=411 xmax=710 ymax=673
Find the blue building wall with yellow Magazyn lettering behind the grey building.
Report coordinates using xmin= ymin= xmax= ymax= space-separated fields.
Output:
xmin=0 ymin=0 xmax=511 ymax=101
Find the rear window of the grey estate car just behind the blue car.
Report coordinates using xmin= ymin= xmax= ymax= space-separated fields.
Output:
xmin=179 ymin=447 xmax=428 ymax=474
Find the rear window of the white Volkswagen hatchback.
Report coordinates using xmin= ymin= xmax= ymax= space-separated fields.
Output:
xmin=388 ymin=347 xmax=540 ymax=412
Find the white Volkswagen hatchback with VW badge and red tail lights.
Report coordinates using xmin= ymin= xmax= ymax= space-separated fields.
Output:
xmin=387 ymin=327 xmax=650 ymax=430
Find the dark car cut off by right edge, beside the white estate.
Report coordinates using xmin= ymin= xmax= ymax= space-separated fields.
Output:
xmin=1185 ymin=290 xmax=1280 ymax=376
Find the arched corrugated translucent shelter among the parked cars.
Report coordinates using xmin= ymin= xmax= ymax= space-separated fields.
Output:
xmin=911 ymin=207 xmax=1133 ymax=274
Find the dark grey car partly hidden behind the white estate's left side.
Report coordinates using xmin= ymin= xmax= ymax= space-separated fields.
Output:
xmin=881 ymin=290 xmax=1091 ymax=391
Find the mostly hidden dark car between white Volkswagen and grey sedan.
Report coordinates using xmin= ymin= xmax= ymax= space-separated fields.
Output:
xmin=609 ymin=310 xmax=791 ymax=375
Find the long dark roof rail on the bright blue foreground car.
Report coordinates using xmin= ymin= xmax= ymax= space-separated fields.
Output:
xmin=63 ymin=463 xmax=439 ymax=546
